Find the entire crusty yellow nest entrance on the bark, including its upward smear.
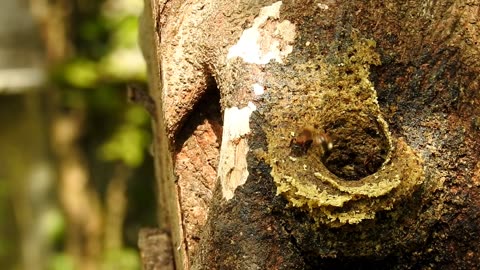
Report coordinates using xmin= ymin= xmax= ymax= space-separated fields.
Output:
xmin=265 ymin=32 xmax=423 ymax=226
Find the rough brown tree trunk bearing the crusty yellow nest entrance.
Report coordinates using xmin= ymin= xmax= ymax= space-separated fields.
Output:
xmin=141 ymin=0 xmax=480 ymax=269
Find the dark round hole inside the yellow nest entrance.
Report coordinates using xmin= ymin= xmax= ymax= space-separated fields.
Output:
xmin=322 ymin=112 xmax=391 ymax=181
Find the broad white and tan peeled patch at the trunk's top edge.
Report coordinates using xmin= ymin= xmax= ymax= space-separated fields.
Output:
xmin=227 ymin=1 xmax=295 ymax=65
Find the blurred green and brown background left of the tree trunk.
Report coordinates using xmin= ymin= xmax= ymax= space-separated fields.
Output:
xmin=0 ymin=0 xmax=157 ymax=270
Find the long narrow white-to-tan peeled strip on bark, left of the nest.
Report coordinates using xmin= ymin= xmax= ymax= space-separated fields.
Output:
xmin=218 ymin=102 xmax=257 ymax=201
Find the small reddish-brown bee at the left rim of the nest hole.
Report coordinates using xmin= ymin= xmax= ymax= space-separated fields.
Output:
xmin=290 ymin=127 xmax=333 ymax=156
